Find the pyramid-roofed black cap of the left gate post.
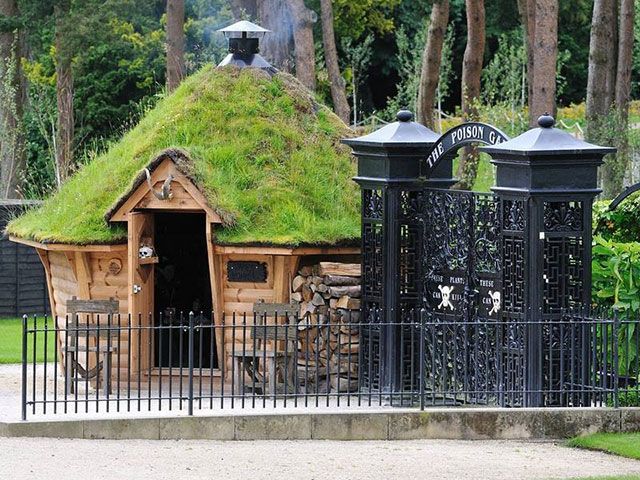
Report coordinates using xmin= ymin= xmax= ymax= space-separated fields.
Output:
xmin=342 ymin=110 xmax=440 ymax=181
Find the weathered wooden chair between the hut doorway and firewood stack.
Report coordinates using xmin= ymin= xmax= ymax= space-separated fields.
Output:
xmin=232 ymin=302 xmax=300 ymax=395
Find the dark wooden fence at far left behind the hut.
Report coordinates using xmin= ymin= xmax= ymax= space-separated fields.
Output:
xmin=0 ymin=201 xmax=50 ymax=318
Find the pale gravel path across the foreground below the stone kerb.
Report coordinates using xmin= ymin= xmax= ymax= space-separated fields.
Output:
xmin=0 ymin=438 xmax=640 ymax=480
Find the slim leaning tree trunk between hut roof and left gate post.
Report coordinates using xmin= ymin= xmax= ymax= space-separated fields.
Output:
xmin=320 ymin=0 xmax=351 ymax=124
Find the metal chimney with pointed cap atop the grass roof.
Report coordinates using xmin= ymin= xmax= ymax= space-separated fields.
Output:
xmin=218 ymin=20 xmax=275 ymax=70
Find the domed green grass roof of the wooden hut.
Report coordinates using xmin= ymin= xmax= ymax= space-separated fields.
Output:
xmin=7 ymin=66 xmax=360 ymax=246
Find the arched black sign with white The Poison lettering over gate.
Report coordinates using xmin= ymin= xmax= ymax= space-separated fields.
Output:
xmin=420 ymin=122 xmax=509 ymax=178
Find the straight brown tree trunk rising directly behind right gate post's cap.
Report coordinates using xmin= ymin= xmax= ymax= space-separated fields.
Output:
xmin=529 ymin=0 xmax=558 ymax=125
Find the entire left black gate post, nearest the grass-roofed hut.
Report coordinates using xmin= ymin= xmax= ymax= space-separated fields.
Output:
xmin=343 ymin=110 xmax=440 ymax=403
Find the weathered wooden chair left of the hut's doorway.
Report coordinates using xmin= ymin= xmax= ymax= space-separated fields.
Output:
xmin=62 ymin=297 xmax=119 ymax=395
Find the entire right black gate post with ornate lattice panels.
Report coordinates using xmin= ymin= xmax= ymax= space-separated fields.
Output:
xmin=479 ymin=114 xmax=616 ymax=407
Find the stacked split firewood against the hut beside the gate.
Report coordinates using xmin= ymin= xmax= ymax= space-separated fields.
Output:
xmin=291 ymin=262 xmax=362 ymax=393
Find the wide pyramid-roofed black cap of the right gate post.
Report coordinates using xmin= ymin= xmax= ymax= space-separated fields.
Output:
xmin=478 ymin=114 xmax=616 ymax=193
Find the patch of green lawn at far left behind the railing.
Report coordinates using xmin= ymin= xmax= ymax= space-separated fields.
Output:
xmin=0 ymin=318 xmax=55 ymax=363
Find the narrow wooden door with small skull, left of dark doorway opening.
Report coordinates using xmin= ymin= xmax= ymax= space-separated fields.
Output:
xmin=128 ymin=212 xmax=157 ymax=372
